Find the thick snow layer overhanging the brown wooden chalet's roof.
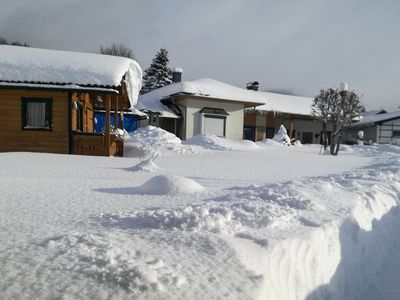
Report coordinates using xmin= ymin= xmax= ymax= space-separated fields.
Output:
xmin=0 ymin=45 xmax=142 ymax=106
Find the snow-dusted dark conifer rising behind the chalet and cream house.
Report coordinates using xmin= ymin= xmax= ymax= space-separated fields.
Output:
xmin=140 ymin=48 xmax=172 ymax=94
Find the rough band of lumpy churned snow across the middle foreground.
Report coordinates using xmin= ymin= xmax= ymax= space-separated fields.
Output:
xmin=101 ymin=180 xmax=321 ymax=237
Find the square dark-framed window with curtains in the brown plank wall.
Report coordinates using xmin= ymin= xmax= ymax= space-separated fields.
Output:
xmin=22 ymin=98 xmax=53 ymax=130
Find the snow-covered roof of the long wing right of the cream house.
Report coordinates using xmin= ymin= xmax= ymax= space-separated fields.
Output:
xmin=257 ymin=92 xmax=314 ymax=116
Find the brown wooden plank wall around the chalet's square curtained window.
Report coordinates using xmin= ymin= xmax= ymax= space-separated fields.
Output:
xmin=0 ymin=89 xmax=69 ymax=153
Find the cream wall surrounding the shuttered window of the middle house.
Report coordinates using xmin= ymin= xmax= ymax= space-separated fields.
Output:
xmin=179 ymin=98 xmax=244 ymax=140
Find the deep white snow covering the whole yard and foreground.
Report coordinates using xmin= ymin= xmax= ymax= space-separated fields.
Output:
xmin=0 ymin=128 xmax=400 ymax=299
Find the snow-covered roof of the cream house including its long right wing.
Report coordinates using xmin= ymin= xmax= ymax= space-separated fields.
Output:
xmin=136 ymin=78 xmax=313 ymax=116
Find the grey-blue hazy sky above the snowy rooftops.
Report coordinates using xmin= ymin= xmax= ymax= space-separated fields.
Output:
xmin=0 ymin=0 xmax=400 ymax=110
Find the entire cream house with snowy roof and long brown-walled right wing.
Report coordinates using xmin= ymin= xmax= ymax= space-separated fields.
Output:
xmin=136 ymin=79 xmax=330 ymax=144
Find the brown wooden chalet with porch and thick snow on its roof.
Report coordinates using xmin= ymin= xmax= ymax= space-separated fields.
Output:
xmin=0 ymin=46 xmax=141 ymax=156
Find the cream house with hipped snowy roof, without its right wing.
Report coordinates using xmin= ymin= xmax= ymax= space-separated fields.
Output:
xmin=136 ymin=78 xmax=265 ymax=140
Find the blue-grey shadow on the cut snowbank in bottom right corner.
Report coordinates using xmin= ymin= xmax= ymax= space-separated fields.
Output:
xmin=306 ymin=206 xmax=400 ymax=300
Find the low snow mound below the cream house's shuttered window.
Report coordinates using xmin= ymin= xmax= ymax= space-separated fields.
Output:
xmin=184 ymin=134 xmax=259 ymax=151
